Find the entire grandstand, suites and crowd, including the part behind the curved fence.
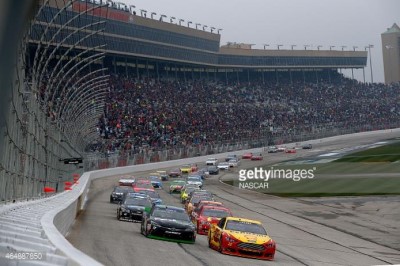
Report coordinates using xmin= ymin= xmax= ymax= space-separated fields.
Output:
xmin=0 ymin=0 xmax=400 ymax=200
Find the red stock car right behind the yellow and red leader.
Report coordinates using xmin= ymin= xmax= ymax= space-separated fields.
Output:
xmin=192 ymin=205 xmax=232 ymax=235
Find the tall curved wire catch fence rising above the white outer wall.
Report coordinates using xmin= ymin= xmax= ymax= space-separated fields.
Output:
xmin=0 ymin=0 xmax=108 ymax=202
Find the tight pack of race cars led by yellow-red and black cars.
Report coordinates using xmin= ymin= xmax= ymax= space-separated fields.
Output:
xmin=110 ymin=156 xmax=276 ymax=260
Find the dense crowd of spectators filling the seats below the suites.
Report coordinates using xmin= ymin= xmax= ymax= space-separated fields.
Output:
xmin=91 ymin=73 xmax=400 ymax=152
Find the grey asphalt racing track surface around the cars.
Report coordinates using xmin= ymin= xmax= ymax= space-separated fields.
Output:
xmin=67 ymin=132 xmax=400 ymax=266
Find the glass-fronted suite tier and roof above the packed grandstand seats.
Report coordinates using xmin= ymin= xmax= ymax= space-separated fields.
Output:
xmin=30 ymin=0 xmax=367 ymax=82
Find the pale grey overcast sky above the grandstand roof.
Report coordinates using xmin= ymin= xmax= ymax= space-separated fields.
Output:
xmin=120 ymin=0 xmax=400 ymax=82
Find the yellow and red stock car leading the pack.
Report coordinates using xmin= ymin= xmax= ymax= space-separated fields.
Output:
xmin=208 ymin=217 xmax=276 ymax=260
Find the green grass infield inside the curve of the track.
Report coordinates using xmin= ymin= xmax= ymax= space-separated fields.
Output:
xmin=228 ymin=142 xmax=400 ymax=197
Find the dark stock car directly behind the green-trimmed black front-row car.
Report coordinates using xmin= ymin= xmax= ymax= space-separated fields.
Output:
xmin=117 ymin=197 xmax=153 ymax=221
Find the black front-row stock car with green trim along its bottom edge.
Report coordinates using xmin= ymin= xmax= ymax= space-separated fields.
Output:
xmin=140 ymin=205 xmax=196 ymax=243
